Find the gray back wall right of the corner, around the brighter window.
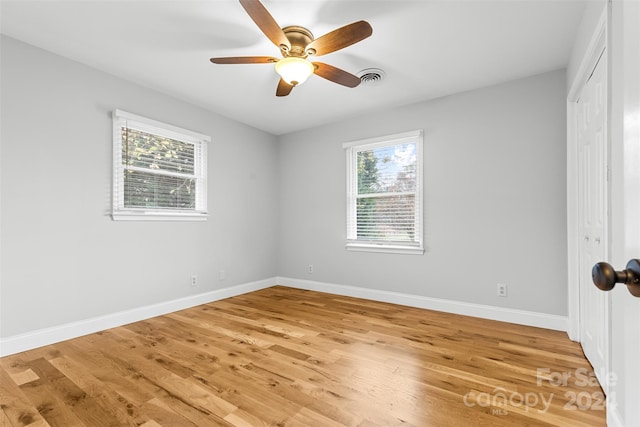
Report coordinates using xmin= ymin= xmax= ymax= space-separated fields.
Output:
xmin=278 ymin=70 xmax=567 ymax=315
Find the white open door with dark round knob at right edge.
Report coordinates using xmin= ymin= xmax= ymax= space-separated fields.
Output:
xmin=607 ymin=1 xmax=640 ymax=427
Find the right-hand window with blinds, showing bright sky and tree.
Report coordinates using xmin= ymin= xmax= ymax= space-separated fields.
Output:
xmin=343 ymin=131 xmax=424 ymax=254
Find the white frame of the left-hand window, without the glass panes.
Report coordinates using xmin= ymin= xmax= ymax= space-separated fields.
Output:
xmin=111 ymin=109 xmax=211 ymax=221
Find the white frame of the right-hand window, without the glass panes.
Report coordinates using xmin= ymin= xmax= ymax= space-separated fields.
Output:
xmin=342 ymin=130 xmax=424 ymax=255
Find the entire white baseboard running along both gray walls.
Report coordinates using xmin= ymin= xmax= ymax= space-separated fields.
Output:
xmin=0 ymin=277 xmax=568 ymax=357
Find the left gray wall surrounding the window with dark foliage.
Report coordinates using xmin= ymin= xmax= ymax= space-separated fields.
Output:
xmin=0 ymin=37 xmax=278 ymax=337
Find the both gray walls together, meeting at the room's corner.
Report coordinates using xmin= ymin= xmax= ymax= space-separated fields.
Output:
xmin=0 ymin=37 xmax=567 ymax=337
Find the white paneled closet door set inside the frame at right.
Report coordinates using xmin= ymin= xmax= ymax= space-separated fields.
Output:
xmin=577 ymin=50 xmax=609 ymax=392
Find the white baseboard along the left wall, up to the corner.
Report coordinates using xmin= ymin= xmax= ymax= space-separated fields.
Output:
xmin=0 ymin=278 xmax=276 ymax=357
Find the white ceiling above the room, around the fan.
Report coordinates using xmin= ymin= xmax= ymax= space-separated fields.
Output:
xmin=0 ymin=0 xmax=585 ymax=135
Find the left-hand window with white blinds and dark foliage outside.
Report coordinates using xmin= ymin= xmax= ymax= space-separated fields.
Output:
xmin=112 ymin=110 xmax=211 ymax=220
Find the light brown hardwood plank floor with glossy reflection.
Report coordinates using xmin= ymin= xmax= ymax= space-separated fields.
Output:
xmin=0 ymin=287 xmax=605 ymax=427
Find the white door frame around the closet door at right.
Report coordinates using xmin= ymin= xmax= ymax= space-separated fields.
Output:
xmin=567 ymin=7 xmax=611 ymax=374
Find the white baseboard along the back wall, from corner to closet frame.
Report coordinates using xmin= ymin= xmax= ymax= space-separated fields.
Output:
xmin=278 ymin=277 xmax=568 ymax=332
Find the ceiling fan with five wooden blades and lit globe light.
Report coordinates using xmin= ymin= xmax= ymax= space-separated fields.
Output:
xmin=211 ymin=0 xmax=373 ymax=96
